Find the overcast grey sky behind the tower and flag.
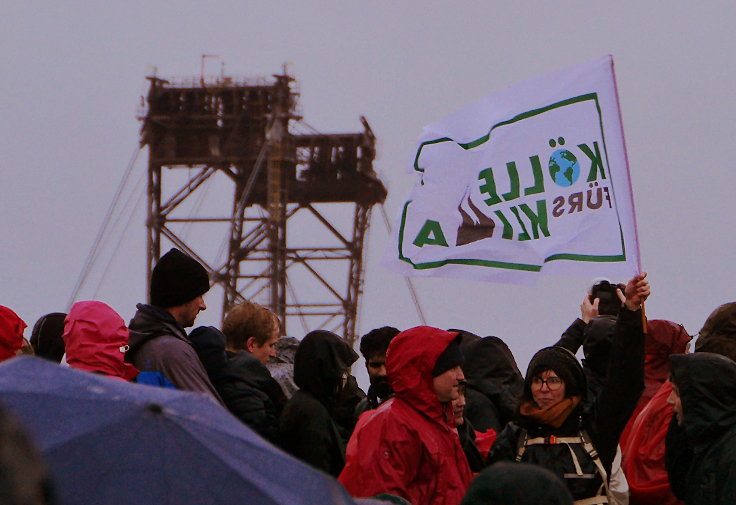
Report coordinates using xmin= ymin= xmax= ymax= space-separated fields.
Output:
xmin=0 ymin=0 xmax=736 ymax=382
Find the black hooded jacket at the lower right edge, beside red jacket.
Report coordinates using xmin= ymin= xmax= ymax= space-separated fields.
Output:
xmin=665 ymin=352 xmax=736 ymax=505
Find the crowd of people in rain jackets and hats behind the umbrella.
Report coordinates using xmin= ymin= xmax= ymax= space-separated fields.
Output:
xmin=0 ymin=249 xmax=736 ymax=505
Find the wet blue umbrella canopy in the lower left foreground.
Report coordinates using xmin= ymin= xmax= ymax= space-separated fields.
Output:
xmin=0 ymin=357 xmax=354 ymax=505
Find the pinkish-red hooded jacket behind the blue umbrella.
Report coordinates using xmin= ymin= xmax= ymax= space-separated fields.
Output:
xmin=62 ymin=301 xmax=138 ymax=381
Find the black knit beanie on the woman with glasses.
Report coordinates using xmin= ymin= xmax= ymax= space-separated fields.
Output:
xmin=524 ymin=346 xmax=587 ymax=399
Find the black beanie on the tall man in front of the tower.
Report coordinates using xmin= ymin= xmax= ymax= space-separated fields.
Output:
xmin=151 ymin=248 xmax=210 ymax=309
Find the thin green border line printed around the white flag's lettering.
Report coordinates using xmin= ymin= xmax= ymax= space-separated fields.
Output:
xmin=399 ymin=93 xmax=626 ymax=272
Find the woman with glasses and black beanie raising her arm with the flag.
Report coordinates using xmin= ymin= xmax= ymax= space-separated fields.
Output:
xmin=489 ymin=273 xmax=649 ymax=505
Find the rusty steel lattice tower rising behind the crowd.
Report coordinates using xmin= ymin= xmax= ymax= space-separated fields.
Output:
xmin=141 ymin=72 xmax=386 ymax=345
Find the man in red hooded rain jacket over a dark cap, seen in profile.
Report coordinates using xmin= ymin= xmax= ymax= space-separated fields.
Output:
xmin=339 ymin=326 xmax=472 ymax=505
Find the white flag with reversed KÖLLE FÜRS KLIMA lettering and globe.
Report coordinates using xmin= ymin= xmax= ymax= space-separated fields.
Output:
xmin=383 ymin=55 xmax=639 ymax=284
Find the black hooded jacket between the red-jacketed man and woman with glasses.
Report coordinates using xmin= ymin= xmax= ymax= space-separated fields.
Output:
xmin=463 ymin=337 xmax=524 ymax=432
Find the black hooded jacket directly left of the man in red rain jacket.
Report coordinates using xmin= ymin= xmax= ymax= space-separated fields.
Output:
xmin=279 ymin=330 xmax=358 ymax=477
